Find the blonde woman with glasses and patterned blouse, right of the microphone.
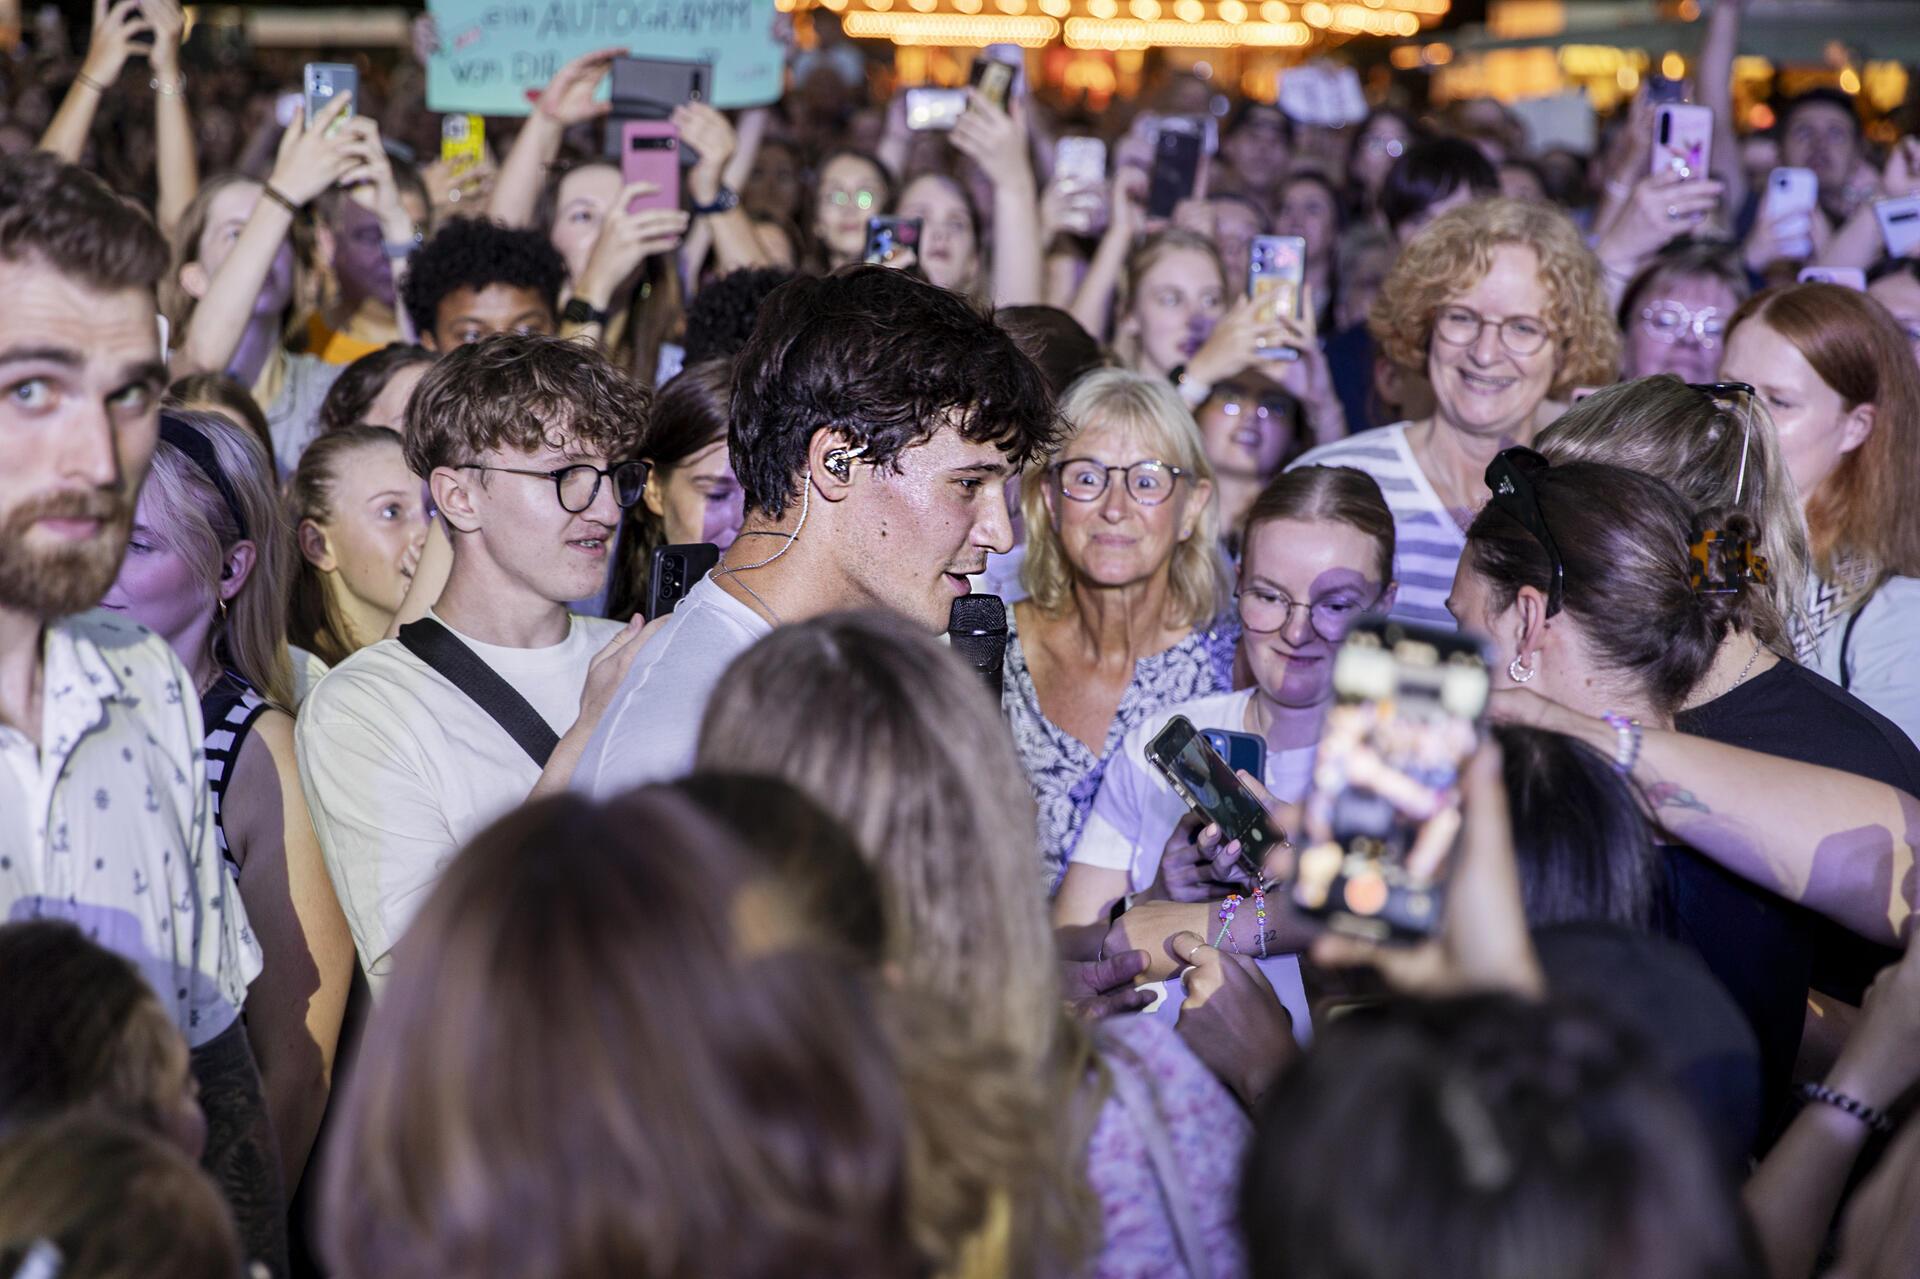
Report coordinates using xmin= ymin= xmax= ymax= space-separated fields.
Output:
xmin=1002 ymin=369 xmax=1240 ymax=889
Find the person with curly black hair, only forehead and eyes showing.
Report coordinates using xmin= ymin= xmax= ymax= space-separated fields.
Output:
xmin=401 ymin=217 xmax=566 ymax=351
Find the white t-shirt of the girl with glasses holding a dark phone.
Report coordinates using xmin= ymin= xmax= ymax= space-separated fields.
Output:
xmin=1068 ymin=688 xmax=1315 ymax=1043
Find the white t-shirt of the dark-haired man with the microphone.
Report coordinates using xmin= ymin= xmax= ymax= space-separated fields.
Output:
xmin=572 ymin=576 xmax=774 ymax=799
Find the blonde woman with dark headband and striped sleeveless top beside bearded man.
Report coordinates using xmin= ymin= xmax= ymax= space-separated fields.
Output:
xmin=102 ymin=411 xmax=353 ymax=1187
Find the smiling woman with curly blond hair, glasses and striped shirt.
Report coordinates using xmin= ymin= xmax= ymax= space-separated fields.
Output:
xmin=1296 ymin=200 xmax=1620 ymax=626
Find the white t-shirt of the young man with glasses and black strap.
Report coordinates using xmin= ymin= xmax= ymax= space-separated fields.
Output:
xmin=294 ymin=616 xmax=620 ymax=995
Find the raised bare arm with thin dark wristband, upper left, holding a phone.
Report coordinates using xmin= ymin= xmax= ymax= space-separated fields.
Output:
xmin=173 ymin=94 xmax=361 ymax=376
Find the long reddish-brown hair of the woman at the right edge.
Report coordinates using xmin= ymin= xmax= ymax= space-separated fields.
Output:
xmin=1726 ymin=284 xmax=1920 ymax=586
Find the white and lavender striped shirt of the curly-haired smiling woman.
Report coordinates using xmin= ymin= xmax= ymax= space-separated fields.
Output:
xmin=1288 ymin=422 xmax=1467 ymax=630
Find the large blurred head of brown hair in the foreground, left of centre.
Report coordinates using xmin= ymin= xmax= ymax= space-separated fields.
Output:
xmin=323 ymin=787 xmax=914 ymax=1279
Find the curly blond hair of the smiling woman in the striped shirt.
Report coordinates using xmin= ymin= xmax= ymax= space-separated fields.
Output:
xmin=1367 ymin=198 xmax=1620 ymax=399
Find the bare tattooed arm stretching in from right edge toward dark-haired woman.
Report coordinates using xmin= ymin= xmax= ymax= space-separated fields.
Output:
xmin=1494 ymin=689 xmax=1920 ymax=945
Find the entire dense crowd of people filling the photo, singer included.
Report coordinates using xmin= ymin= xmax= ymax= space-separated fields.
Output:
xmin=0 ymin=0 xmax=1920 ymax=1279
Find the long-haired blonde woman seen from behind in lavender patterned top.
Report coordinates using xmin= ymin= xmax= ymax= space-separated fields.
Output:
xmin=697 ymin=613 xmax=1248 ymax=1277
